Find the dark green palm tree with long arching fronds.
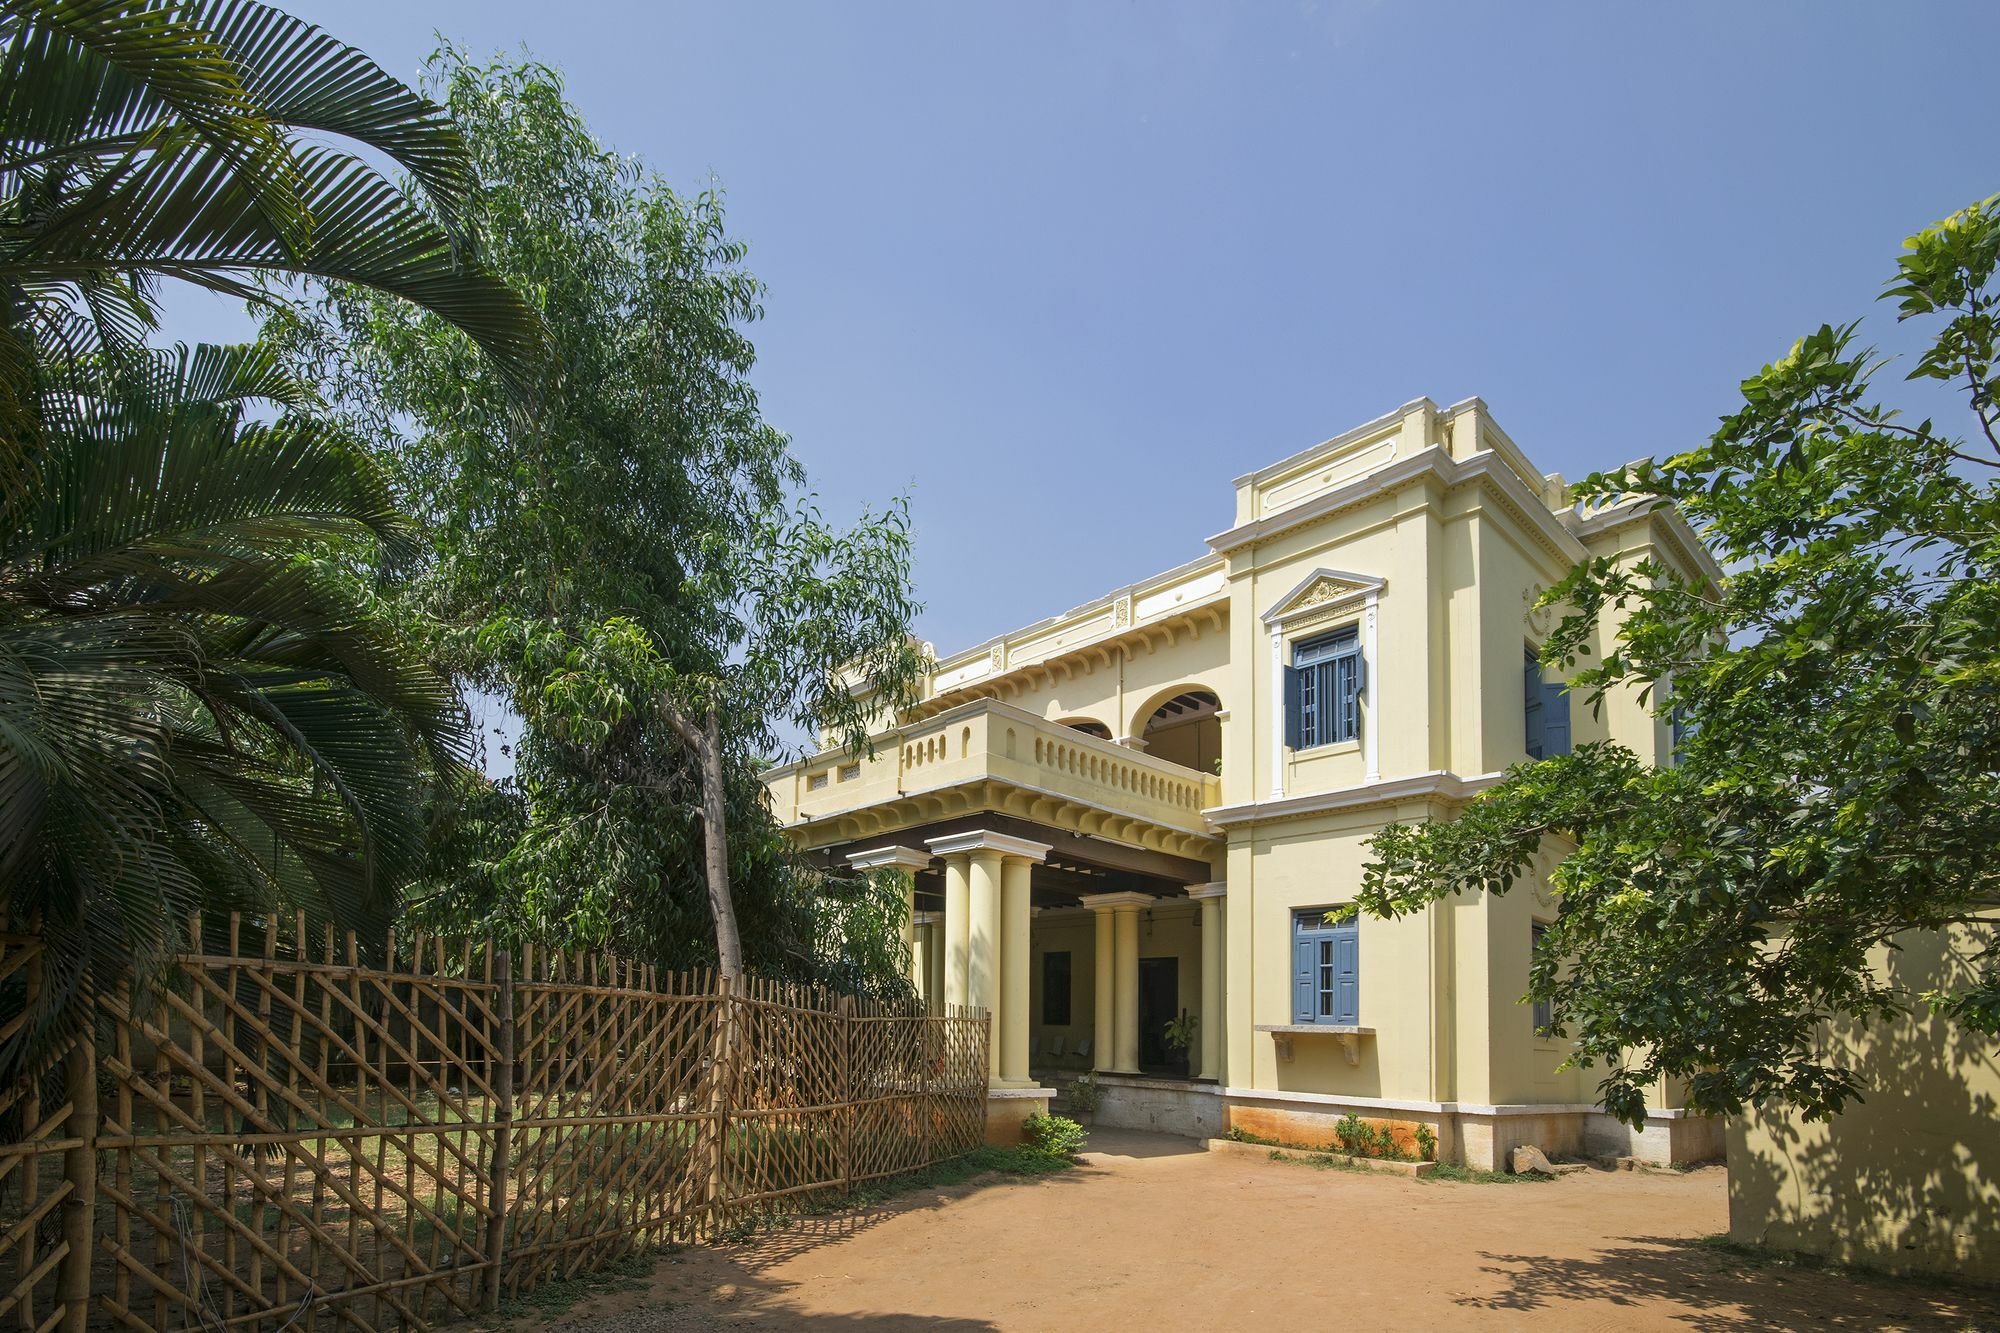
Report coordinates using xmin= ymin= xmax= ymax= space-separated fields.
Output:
xmin=0 ymin=0 xmax=542 ymax=1075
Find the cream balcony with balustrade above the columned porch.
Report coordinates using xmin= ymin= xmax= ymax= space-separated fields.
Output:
xmin=764 ymin=699 xmax=1222 ymax=859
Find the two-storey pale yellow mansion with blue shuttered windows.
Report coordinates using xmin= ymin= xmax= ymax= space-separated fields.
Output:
xmin=768 ymin=398 xmax=1722 ymax=1167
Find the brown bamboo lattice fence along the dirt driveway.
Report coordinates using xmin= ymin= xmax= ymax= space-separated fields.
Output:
xmin=0 ymin=919 xmax=988 ymax=1333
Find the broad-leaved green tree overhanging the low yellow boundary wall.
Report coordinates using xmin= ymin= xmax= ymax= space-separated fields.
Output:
xmin=1362 ymin=198 xmax=2000 ymax=1123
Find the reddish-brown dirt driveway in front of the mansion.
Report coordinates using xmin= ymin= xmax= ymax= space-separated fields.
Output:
xmin=492 ymin=1129 xmax=2000 ymax=1333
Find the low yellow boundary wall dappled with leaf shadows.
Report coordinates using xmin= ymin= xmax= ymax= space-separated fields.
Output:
xmin=1728 ymin=927 xmax=2000 ymax=1281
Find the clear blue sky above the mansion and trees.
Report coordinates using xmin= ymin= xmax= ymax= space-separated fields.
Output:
xmin=168 ymin=0 xmax=2000 ymax=652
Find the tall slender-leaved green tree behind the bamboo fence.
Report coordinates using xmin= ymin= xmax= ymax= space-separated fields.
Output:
xmin=266 ymin=48 xmax=922 ymax=985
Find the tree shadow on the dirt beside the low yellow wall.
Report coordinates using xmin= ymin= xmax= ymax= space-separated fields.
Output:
xmin=1458 ymin=1237 xmax=2000 ymax=1333
